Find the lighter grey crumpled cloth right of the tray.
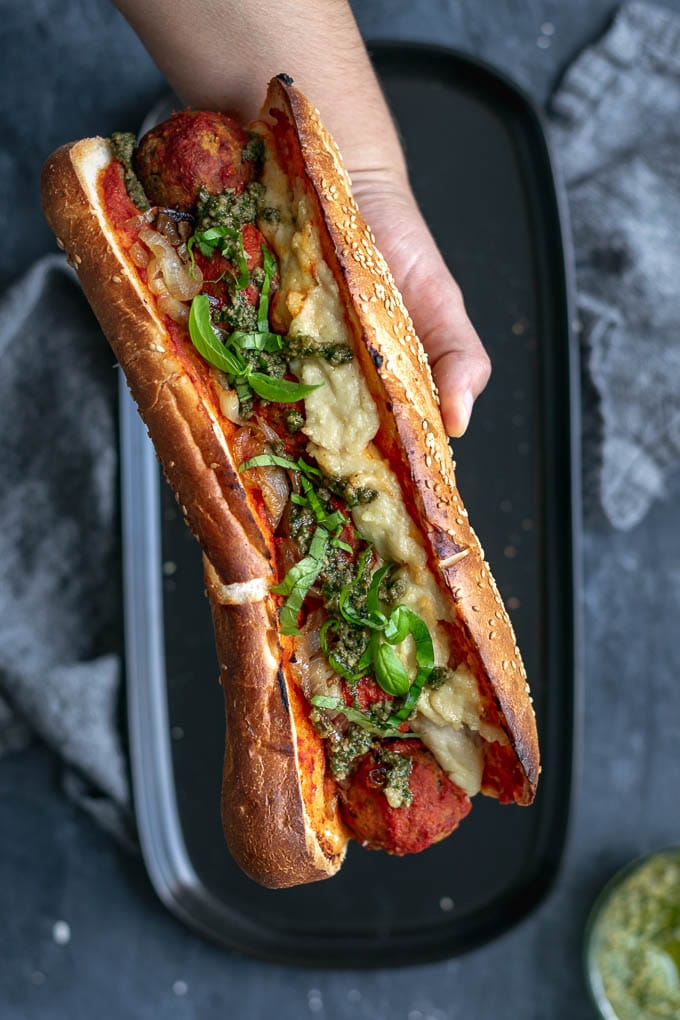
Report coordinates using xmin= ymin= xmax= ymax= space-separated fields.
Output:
xmin=553 ymin=3 xmax=680 ymax=528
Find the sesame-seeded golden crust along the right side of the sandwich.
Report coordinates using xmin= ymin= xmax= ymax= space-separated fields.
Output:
xmin=265 ymin=77 xmax=540 ymax=804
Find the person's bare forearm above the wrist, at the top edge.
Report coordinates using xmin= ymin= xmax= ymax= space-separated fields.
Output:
xmin=115 ymin=0 xmax=406 ymax=179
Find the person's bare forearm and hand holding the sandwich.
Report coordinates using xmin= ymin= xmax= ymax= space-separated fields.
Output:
xmin=116 ymin=0 xmax=490 ymax=437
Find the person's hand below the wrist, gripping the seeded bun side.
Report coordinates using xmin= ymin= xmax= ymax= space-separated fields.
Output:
xmin=360 ymin=184 xmax=491 ymax=437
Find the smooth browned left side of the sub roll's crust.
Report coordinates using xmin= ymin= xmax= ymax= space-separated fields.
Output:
xmin=42 ymin=139 xmax=348 ymax=887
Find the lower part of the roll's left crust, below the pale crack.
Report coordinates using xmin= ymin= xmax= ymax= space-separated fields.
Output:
xmin=204 ymin=560 xmax=348 ymax=888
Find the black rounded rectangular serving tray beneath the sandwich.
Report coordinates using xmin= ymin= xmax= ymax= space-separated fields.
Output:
xmin=121 ymin=44 xmax=579 ymax=967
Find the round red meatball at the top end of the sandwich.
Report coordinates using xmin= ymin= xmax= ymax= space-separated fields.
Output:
xmin=134 ymin=110 xmax=254 ymax=210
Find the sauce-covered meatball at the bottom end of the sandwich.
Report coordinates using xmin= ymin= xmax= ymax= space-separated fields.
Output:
xmin=341 ymin=740 xmax=472 ymax=856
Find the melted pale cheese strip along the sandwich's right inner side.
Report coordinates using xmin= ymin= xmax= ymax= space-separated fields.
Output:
xmin=261 ymin=141 xmax=497 ymax=796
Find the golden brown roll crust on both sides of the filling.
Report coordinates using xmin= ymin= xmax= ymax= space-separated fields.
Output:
xmin=43 ymin=80 xmax=539 ymax=887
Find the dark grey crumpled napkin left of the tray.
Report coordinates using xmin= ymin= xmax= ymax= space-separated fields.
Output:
xmin=0 ymin=255 xmax=128 ymax=835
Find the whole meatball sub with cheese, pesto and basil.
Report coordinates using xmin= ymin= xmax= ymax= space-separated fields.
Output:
xmin=42 ymin=75 xmax=539 ymax=887
